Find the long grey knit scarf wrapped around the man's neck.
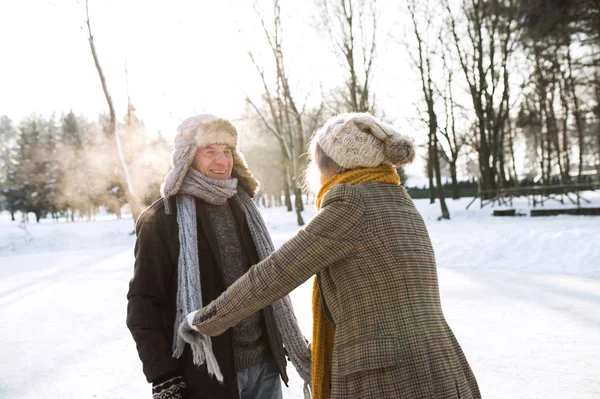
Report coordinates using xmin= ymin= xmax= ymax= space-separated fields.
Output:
xmin=173 ymin=168 xmax=311 ymax=397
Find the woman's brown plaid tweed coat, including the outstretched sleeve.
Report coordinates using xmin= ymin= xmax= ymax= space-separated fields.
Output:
xmin=193 ymin=183 xmax=480 ymax=399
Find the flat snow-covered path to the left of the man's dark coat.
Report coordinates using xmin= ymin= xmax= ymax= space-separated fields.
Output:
xmin=0 ymin=246 xmax=141 ymax=399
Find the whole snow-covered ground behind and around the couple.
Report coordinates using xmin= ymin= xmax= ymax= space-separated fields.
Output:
xmin=0 ymin=193 xmax=600 ymax=399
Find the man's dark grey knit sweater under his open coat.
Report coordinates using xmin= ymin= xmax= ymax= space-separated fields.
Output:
xmin=206 ymin=203 xmax=270 ymax=371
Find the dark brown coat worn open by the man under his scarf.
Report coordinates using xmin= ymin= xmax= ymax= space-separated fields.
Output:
xmin=127 ymin=198 xmax=288 ymax=399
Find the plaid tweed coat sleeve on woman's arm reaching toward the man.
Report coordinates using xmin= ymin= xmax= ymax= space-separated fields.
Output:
xmin=190 ymin=185 xmax=364 ymax=336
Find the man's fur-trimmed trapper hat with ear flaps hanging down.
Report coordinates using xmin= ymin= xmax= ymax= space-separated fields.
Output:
xmin=161 ymin=114 xmax=259 ymax=205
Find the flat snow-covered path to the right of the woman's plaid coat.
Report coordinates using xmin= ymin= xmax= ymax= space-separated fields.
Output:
xmin=439 ymin=269 xmax=600 ymax=399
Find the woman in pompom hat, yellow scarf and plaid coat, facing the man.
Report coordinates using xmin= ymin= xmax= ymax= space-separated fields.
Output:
xmin=182 ymin=114 xmax=481 ymax=399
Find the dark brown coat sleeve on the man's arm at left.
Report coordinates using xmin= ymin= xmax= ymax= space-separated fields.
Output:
xmin=127 ymin=208 xmax=177 ymax=382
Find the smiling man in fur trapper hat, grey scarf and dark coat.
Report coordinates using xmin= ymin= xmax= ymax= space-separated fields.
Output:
xmin=127 ymin=115 xmax=311 ymax=399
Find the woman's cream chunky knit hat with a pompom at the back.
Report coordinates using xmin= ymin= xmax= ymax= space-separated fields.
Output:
xmin=313 ymin=113 xmax=415 ymax=169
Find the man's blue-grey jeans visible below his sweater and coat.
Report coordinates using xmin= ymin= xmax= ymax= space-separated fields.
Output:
xmin=237 ymin=361 xmax=283 ymax=399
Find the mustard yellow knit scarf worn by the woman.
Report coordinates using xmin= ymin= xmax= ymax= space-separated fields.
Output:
xmin=311 ymin=166 xmax=400 ymax=399
